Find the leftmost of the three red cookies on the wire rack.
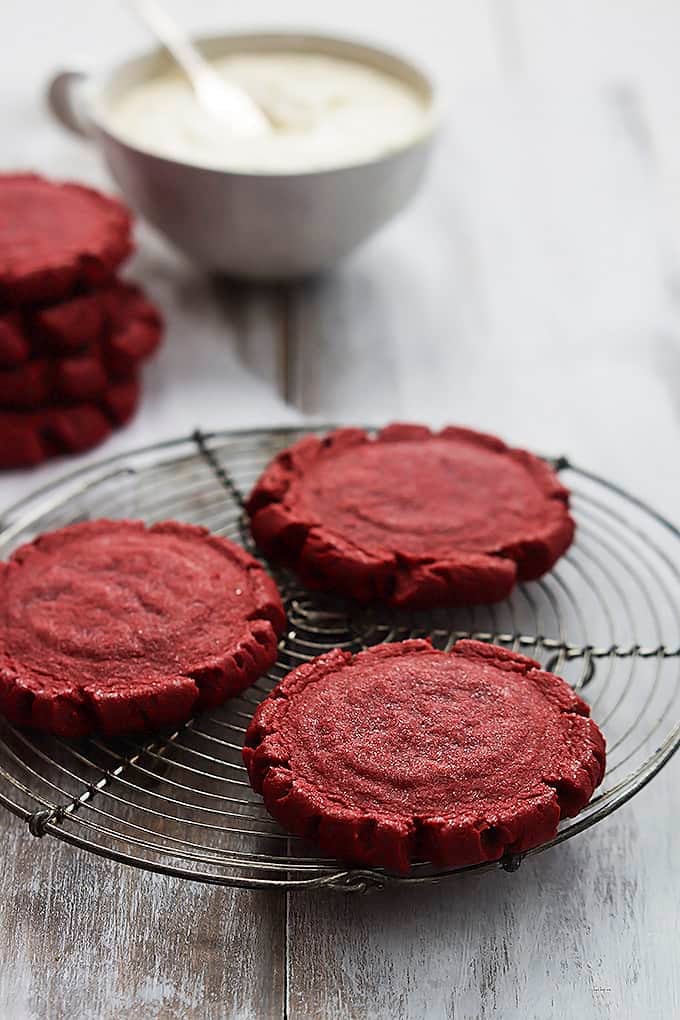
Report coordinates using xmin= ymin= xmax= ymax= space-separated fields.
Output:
xmin=0 ymin=520 xmax=285 ymax=736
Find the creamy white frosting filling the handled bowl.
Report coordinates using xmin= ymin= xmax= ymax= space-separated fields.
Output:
xmin=106 ymin=53 xmax=431 ymax=173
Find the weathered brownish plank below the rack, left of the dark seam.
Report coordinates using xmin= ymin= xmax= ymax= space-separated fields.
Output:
xmin=0 ymin=810 xmax=285 ymax=1020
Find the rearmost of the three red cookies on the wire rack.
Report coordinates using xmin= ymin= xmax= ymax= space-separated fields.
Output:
xmin=248 ymin=424 xmax=574 ymax=607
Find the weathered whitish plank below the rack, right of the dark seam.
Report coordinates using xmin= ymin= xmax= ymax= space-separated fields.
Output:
xmin=290 ymin=766 xmax=680 ymax=1020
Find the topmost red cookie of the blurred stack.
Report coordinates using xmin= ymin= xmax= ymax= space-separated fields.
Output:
xmin=0 ymin=173 xmax=133 ymax=305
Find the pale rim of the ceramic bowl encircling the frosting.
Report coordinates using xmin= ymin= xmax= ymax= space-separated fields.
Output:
xmin=85 ymin=29 xmax=443 ymax=181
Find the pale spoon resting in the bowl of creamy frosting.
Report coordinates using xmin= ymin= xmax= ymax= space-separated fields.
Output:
xmin=129 ymin=0 xmax=271 ymax=135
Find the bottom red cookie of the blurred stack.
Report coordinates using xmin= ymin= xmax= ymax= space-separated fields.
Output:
xmin=0 ymin=378 xmax=140 ymax=468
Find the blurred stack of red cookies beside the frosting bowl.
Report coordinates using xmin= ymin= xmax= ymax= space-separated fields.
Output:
xmin=0 ymin=174 xmax=162 ymax=468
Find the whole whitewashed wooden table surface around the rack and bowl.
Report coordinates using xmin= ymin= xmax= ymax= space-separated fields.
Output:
xmin=0 ymin=0 xmax=680 ymax=1020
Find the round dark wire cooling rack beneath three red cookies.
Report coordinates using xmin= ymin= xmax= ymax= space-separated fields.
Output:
xmin=0 ymin=428 xmax=680 ymax=891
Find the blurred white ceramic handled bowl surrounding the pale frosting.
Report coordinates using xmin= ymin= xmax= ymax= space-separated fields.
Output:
xmin=48 ymin=33 xmax=437 ymax=279
